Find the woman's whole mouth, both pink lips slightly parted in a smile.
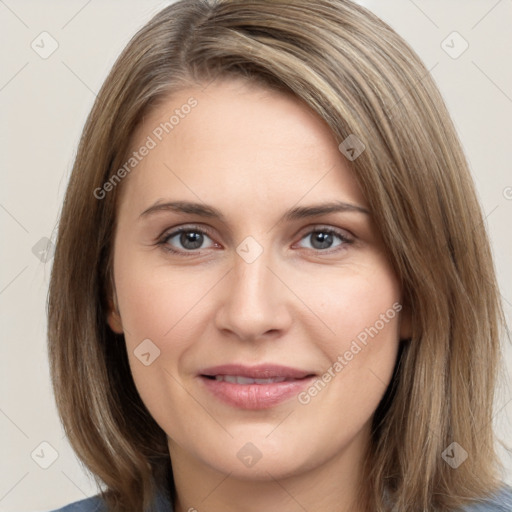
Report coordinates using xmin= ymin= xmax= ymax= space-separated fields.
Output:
xmin=198 ymin=364 xmax=316 ymax=410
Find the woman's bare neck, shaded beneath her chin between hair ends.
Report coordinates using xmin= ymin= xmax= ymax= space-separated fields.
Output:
xmin=169 ymin=431 xmax=369 ymax=512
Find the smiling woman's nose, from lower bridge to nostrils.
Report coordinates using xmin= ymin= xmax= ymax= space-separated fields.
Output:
xmin=215 ymin=246 xmax=293 ymax=341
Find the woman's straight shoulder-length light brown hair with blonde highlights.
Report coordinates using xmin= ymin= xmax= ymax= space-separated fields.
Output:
xmin=48 ymin=0 xmax=505 ymax=512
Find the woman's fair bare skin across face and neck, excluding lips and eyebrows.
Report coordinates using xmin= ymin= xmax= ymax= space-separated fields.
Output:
xmin=108 ymin=80 xmax=408 ymax=512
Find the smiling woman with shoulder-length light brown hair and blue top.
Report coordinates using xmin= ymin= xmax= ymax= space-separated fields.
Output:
xmin=49 ymin=0 xmax=512 ymax=512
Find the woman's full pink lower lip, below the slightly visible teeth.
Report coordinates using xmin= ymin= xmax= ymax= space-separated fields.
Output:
xmin=201 ymin=377 xmax=314 ymax=410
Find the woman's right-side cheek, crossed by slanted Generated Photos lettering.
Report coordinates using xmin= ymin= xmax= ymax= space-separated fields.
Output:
xmin=299 ymin=263 xmax=402 ymax=418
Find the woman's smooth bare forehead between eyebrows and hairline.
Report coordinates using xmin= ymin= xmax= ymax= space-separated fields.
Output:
xmin=118 ymin=80 xmax=365 ymax=219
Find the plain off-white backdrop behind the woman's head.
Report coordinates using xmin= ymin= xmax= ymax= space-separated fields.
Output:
xmin=0 ymin=0 xmax=512 ymax=512
